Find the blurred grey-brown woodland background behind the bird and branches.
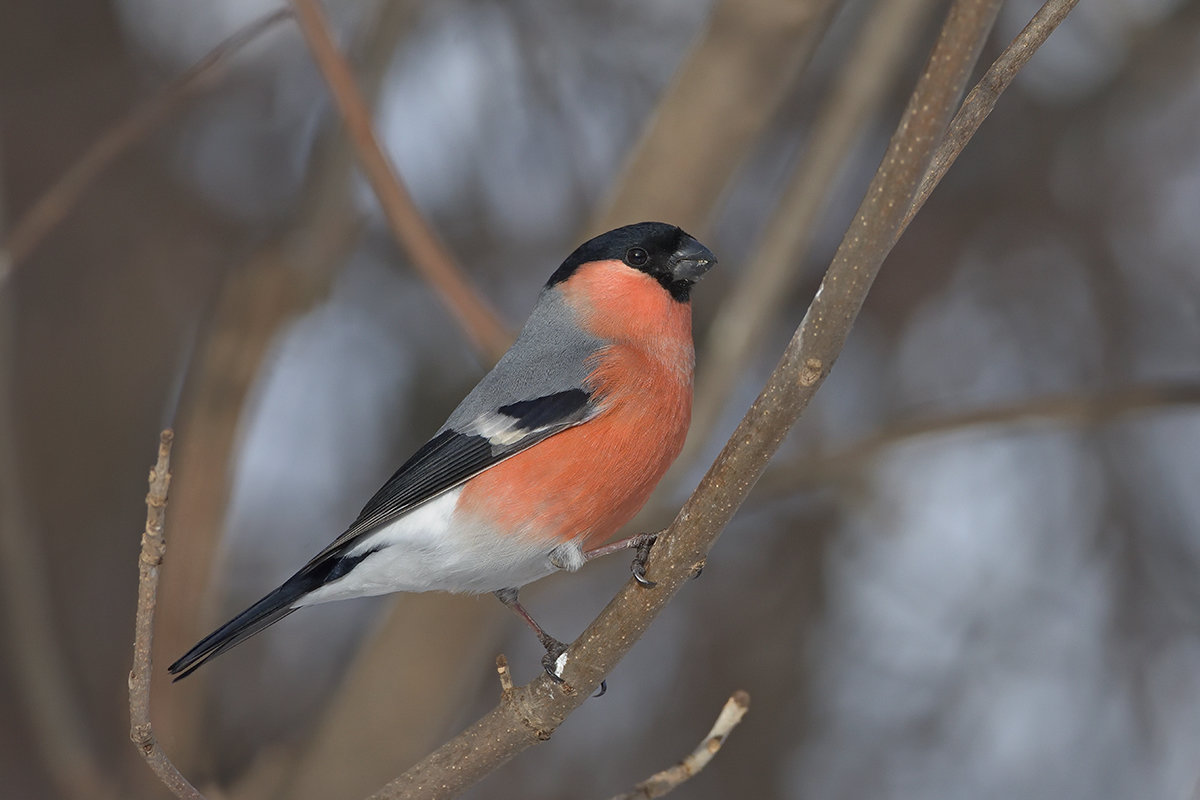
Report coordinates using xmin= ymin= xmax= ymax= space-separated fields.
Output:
xmin=0 ymin=0 xmax=1200 ymax=800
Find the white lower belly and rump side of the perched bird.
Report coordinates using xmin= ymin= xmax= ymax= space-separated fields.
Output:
xmin=294 ymin=488 xmax=573 ymax=607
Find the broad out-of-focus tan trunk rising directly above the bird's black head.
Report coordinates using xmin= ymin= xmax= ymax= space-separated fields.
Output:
xmin=592 ymin=0 xmax=839 ymax=235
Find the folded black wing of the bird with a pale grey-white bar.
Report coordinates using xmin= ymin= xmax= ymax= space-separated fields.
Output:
xmin=308 ymin=389 xmax=600 ymax=565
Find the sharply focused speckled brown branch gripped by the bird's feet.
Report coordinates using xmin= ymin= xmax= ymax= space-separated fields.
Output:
xmin=373 ymin=0 xmax=1017 ymax=800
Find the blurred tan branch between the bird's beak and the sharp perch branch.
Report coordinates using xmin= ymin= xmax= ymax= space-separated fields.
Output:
xmin=681 ymin=0 xmax=932 ymax=470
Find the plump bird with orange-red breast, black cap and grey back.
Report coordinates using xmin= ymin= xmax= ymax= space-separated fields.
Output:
xmin=169 ymin=222 xmax=716 ymax=680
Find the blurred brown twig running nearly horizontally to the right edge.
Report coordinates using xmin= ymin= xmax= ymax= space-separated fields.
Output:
xmin=755 ymin=383 xmax=1200 ymax=499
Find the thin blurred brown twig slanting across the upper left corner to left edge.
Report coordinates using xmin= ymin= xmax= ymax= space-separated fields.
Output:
xmin=0 ymin=8 xmax=292 ymax=288
